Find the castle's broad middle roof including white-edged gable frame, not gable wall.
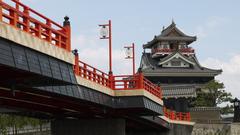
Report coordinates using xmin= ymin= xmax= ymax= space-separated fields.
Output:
xmin=140 ymin=52 xmax=222 ymax=77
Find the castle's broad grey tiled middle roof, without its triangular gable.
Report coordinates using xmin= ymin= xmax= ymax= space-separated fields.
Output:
xmin=141 ymin=53 xmax=222 ymax=76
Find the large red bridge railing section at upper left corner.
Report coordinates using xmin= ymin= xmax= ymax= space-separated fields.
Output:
xmin=0 ymin=0 xmax=71 ymax=51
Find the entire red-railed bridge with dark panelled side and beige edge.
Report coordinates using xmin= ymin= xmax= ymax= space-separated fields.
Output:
xmin=0 ymin=0 xmax=193 ymax=135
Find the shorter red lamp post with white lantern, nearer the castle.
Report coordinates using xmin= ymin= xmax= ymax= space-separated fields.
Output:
xmin=124 ymin=43 xmax=135 ymax=75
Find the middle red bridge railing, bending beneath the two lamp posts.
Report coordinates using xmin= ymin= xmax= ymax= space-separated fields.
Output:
xmin=73 ymin=54 xmax=162 ymax=99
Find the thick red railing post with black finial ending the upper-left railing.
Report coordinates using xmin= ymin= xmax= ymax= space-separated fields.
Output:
xmin=63 ymin=16 xmax=71 ymax=51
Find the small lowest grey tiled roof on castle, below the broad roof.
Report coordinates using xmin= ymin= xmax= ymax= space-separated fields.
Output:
xmin=161 ymin=84 xmax=197 ymax=98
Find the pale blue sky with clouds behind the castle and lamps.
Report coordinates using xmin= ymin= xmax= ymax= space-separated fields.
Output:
xmin=21 ymin=0 xmax=240 ymax=98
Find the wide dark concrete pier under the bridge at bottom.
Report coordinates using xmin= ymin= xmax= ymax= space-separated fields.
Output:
xmin=51 ymin=119 xmax=125 ymax=135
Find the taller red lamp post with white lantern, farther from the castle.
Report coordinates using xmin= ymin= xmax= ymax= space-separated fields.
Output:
xmin=99 ymin=20 xmax=112 ymax=74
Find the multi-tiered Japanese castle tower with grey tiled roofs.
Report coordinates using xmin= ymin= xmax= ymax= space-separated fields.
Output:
xmin=140 ymin=21 xmax=222 ymax=112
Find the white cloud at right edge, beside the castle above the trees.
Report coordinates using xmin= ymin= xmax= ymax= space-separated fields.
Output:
xmin=202 ymin=54 xmax=240 ymax=97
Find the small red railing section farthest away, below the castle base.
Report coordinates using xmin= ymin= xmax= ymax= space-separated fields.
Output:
xmin=163 ymin=108 xmax=191 ymax=121
